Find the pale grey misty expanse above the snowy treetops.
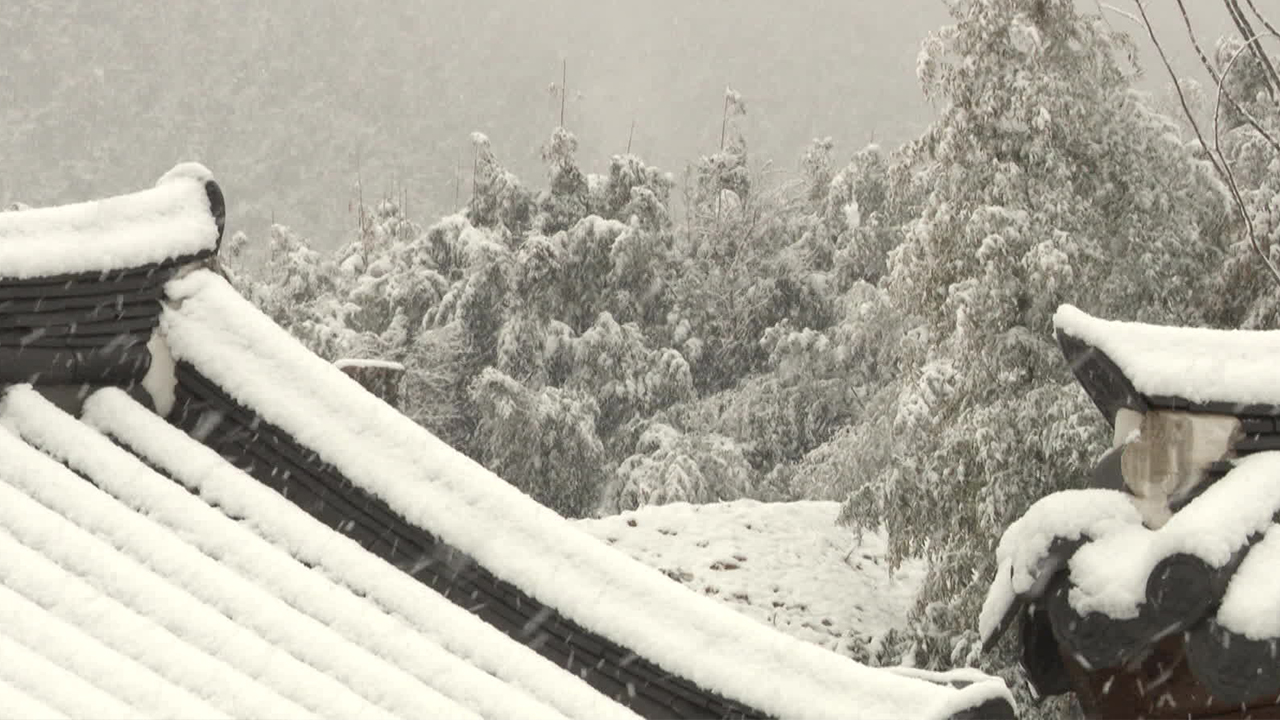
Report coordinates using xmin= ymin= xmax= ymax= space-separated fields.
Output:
xmin=0 ymin=0 xmax=1259 ymax=246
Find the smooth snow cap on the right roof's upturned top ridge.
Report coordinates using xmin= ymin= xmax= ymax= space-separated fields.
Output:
xmin=1053 ymin=305 xmax=1280 ymax=405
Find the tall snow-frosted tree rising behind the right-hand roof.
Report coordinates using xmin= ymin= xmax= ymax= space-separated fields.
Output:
xmin=814 ymin=0 xmax=1226 ymax=665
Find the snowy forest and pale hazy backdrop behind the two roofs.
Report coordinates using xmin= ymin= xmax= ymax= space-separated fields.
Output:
xmin=0 ymin=0 xmax=1280 ymax=707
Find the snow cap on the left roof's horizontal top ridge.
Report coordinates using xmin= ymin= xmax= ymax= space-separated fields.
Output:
xmin=0 ymin=163 xmax=218 ymax=278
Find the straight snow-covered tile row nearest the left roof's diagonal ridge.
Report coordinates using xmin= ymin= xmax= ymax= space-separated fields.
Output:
xmin=83 ymin=388 xmax=636 ymax=720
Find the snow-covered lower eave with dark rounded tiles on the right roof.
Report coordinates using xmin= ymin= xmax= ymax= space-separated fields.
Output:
xmin=980 ymin=452 xmax=1280 ymax=702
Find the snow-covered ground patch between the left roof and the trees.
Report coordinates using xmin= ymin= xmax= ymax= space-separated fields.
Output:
xmin=579 ymin=500 xmax=924 ymax=657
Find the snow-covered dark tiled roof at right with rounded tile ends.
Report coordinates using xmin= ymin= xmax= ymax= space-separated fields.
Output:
xmin=980 ymin=307 xmax=1280 ymax=716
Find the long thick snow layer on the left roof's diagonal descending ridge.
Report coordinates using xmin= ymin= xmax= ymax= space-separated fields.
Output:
xmin=161 ymin=270 xmax=1011 ymax=719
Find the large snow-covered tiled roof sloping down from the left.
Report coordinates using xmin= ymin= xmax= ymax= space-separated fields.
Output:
xmin=0 ymin=165 xmax=1012 ymax=719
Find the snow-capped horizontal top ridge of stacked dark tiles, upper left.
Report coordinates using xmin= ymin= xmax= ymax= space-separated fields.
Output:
xmin=0 ymin=163 xmax=225 ymax=384
